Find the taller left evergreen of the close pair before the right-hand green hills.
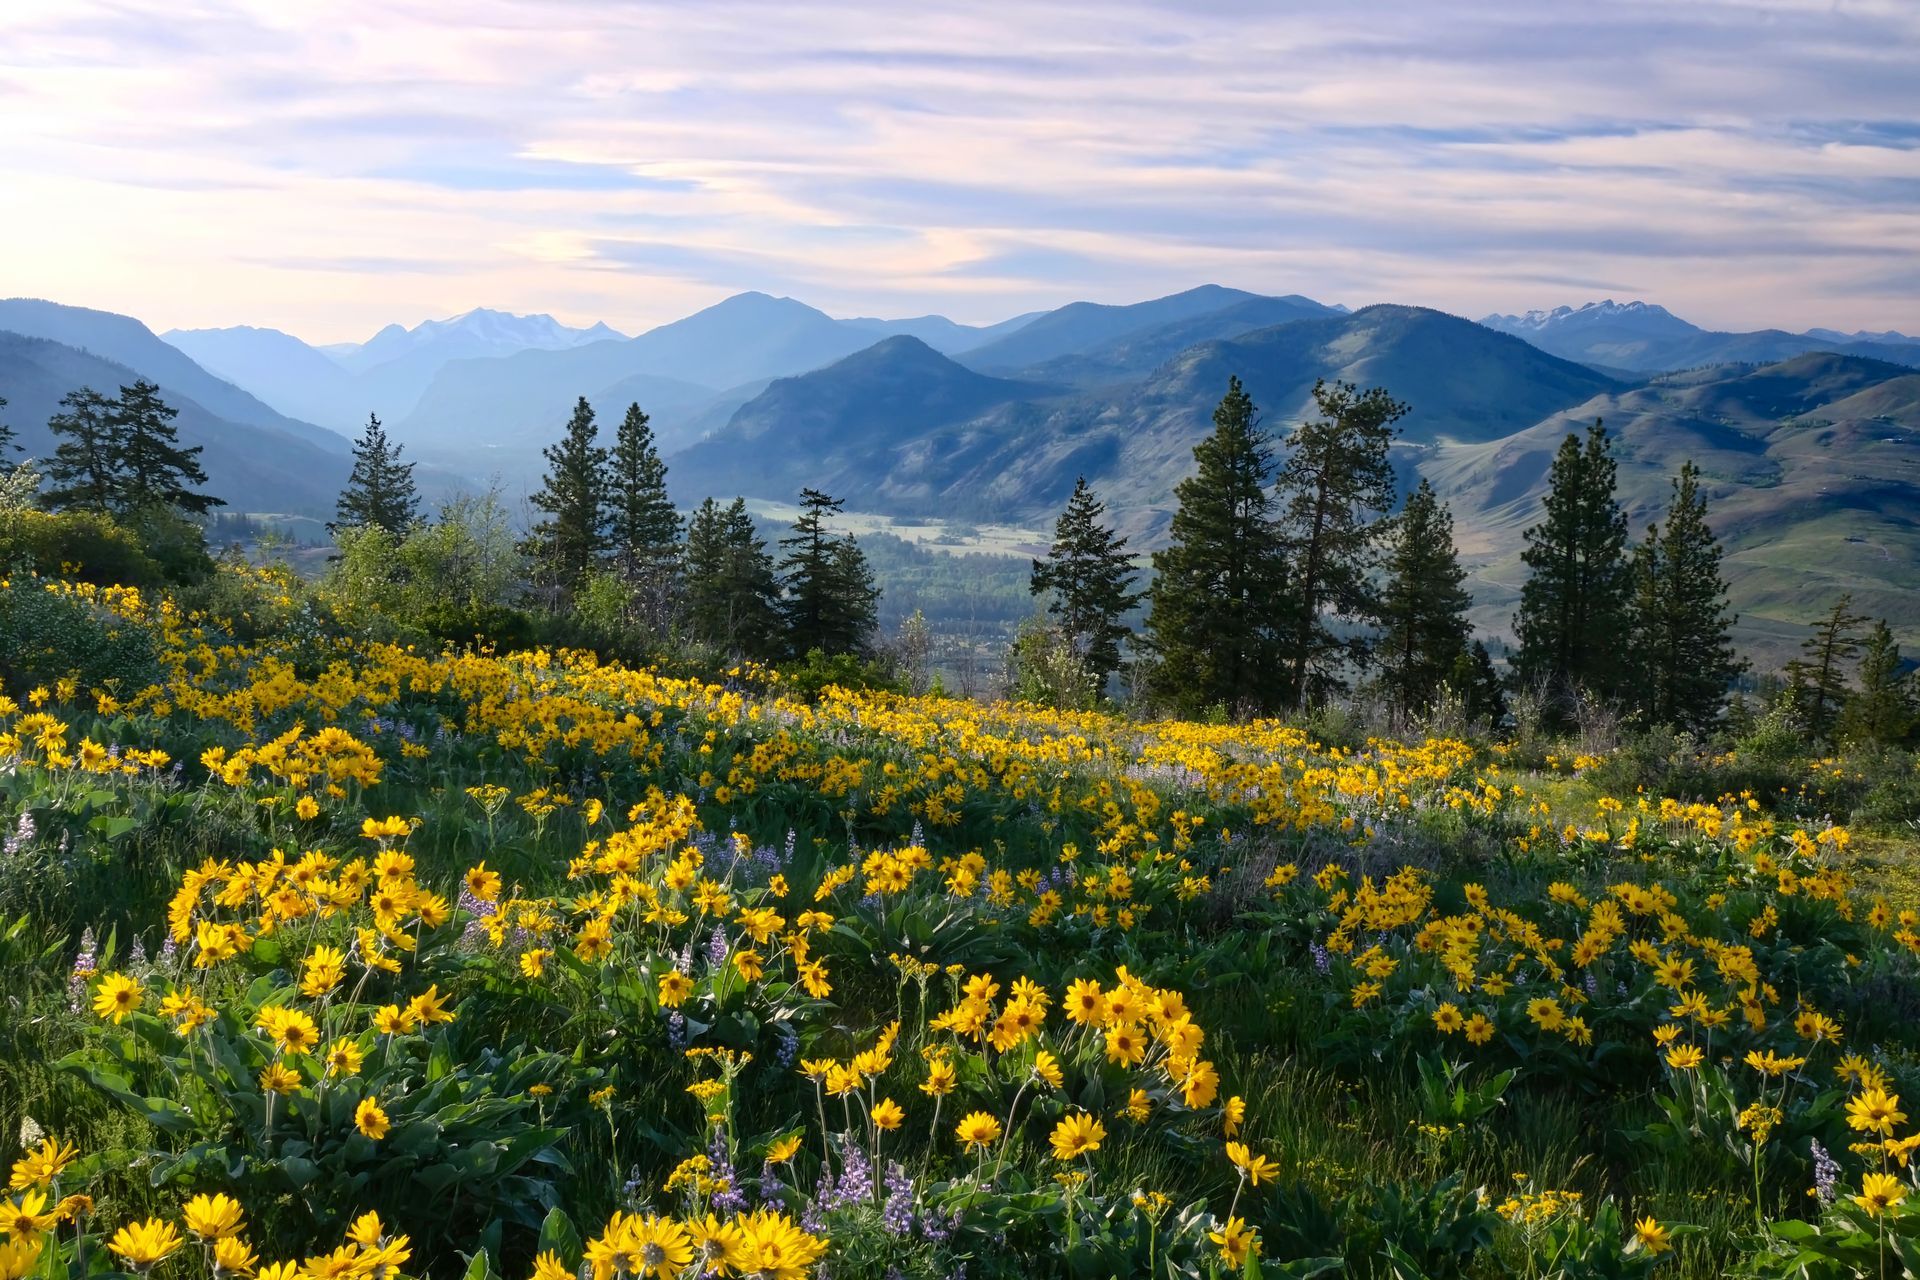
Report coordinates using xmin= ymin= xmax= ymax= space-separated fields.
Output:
xmin=1513 ymin=420 xmax=1632 ymax=700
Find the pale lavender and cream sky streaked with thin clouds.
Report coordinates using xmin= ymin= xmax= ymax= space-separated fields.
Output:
xmin=0 ymin=0 xmax=1920 ymax=342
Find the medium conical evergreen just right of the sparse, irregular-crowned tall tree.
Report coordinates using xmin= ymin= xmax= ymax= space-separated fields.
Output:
xmin=1375 ymin=480 xmax=1466 ymax=716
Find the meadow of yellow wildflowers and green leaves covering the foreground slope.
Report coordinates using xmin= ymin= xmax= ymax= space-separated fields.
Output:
xmin=0 ymin=564 xmax=1920 ymax=1280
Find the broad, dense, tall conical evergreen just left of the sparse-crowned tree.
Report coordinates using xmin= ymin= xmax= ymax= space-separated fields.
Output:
xmin=1146 ymin=378 xmax=1292 ymax=714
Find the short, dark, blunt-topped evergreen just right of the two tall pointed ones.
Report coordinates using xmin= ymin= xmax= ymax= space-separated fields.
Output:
xmin=684 ymin=497 xmax=781 ymax=660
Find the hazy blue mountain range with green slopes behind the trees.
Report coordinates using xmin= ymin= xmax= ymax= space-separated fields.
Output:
xmin=0 ymin=286 xmax=1920 ymax=656
